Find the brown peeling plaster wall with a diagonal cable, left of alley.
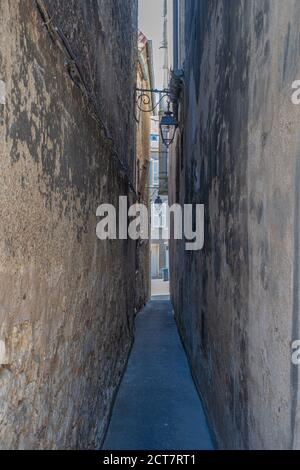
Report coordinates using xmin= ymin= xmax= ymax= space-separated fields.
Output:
xmin=0 ymin=0 xmax=137 ymax=449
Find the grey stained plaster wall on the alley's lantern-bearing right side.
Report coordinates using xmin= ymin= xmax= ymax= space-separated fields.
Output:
xmin=170 ymin=0 xmax=300 ymax=449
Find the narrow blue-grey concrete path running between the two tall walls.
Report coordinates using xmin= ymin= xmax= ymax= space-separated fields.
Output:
xmin=103 ymin=298 xmax=213 ymax=450
